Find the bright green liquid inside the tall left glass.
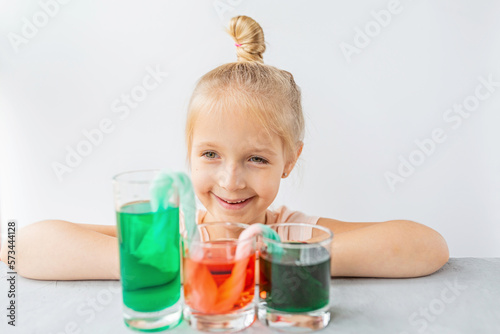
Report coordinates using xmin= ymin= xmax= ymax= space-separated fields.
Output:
xmin=116 ymin=202 xmax=181 ymax=312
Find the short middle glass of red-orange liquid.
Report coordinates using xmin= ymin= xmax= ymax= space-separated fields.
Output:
xmin=182 ymin=222 xmax=256 ymax=332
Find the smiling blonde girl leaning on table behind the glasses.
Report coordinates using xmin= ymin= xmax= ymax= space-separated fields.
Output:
xmin=1 ymin=16 xmax=448 ymax=280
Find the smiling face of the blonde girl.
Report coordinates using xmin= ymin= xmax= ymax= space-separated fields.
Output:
xmin=190 ymin=112 xmax=293 ymax=224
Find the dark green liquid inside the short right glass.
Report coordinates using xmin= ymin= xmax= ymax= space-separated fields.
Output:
xmin=259 ymin=250 xmax=330 ymax=313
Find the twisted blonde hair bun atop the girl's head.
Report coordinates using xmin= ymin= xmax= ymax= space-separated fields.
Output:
xmin=227 ymin=16 xmax=266 ymax=63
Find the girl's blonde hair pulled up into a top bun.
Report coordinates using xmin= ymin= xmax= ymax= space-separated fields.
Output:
xmin=186 ymin=16 xmax=304 ymax=161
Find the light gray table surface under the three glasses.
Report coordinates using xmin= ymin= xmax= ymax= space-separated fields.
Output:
xmin=0 ymin=258 xmax=500 ymax=334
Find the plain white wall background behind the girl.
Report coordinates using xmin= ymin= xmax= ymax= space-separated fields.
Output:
xmin=0 ymin=0 xmax=500 ymax=257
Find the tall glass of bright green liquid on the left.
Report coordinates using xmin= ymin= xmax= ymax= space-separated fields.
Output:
xmin=113 ymin=170 xmax=182 ymax=332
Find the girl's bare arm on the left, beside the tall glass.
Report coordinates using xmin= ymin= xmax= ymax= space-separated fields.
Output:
xmin=0 ymin=220 xmax=120 ymax=280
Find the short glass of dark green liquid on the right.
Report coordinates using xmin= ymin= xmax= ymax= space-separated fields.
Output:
xmin=258 ymin=223 xmax=333 ymax=332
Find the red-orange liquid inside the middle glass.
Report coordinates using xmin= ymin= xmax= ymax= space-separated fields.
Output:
xmin=184 ymin=249 xmax=255 ymax=314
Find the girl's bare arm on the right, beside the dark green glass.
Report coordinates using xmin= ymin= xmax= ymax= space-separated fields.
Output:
xmin=313 ymin=218 xmax=449 ymax=277
